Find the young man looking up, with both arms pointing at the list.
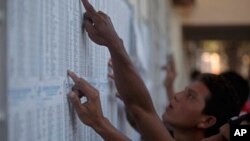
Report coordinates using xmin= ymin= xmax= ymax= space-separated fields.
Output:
xmin=69 ymin=0 xmax=238 ymax=141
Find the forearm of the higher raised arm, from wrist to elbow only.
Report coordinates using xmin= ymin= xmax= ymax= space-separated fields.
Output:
xmin=108 ymin=40 xmax=155 ymax=112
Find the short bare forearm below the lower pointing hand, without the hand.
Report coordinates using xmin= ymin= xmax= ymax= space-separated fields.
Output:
xmin=93 ymin=119 xmax=131 ymax=141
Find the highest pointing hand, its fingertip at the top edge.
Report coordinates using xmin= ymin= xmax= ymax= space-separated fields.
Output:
xmin=82 ymin=0 xmax=121 ymax=47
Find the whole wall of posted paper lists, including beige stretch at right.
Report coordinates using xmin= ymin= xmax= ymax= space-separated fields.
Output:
xmin=5 ymin=0 xmax=180 ymax=141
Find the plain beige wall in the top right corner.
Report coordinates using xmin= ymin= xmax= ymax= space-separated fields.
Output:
xmin=182 ymin=0 xmax=250 ymax=25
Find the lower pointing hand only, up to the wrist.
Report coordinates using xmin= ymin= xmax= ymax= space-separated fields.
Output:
xmin=68 ymin=71 xmax=105 ymax=129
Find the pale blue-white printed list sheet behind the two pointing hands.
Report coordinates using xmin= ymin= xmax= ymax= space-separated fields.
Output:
xmin=7 ymin=0 xmax=131 ymax=141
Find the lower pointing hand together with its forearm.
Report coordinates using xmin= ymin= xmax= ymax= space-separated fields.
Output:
xmin=68 ymin=71 xmax=130 ymax=141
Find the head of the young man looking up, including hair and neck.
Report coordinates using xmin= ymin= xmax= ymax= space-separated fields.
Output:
xmin=163 ymin=74 xmax=238 ymax=140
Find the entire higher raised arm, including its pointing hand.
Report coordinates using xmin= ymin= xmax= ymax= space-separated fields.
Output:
xmin=82 ymin=0 xmax=174 ymax=141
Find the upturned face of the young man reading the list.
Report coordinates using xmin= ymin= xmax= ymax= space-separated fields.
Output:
xmin=162 ymin=81 xmax=209 ymax=129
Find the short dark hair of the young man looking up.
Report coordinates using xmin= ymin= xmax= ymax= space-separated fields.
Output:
xmin=198 ymin=73 xmax=239 ymax=136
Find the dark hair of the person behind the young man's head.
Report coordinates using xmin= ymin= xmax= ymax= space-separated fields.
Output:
xmin=221 ymin=71 xmax=249 ymax=109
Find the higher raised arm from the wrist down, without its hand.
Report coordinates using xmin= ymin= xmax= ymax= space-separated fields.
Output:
xmin=108 ymin=41 xmax=172 ymax=141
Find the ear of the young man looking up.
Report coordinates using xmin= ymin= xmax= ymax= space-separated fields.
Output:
xmin=197 ymin=115 xmax=216 ymax=129
